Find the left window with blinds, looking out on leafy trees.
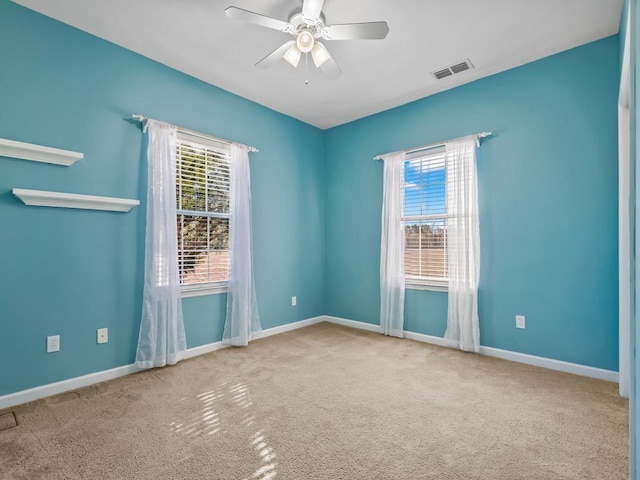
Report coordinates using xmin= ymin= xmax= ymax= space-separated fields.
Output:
xmin=176 ymin=132 xmax=230 ymax=296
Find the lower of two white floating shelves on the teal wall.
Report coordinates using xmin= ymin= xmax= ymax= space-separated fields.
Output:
xmin=13 ymin=188 xmax=140 ymax=212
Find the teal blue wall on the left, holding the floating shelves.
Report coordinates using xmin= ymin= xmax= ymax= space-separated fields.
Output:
xmin=0 ymin=0 xmax=325 ymax=395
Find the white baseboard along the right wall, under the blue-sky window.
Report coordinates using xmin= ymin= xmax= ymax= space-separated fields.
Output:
xmin=325 ymin=317 xmax=618 ymax=383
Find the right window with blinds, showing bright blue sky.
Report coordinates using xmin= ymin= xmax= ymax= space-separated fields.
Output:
xmin=402 ymin=148 xmax=449 ymax=289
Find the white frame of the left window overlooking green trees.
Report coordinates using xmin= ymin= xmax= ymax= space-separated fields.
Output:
xmin=176 ymin=130 xmax=231 ymax=298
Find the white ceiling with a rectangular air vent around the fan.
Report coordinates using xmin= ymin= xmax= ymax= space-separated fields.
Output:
xmin=14 ymin=0 xmax=623 ymax=129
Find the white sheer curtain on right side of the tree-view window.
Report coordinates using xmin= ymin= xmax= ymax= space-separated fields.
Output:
xmin=222 ymin=143 xmax=260 ymax=346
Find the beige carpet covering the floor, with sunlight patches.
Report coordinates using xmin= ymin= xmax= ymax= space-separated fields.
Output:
xmin=0 ymin=323 xmax=628 ymax=480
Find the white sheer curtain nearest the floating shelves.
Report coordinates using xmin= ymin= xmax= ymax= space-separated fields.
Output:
xmin=136 ymin=120 xmax=187 ymax=368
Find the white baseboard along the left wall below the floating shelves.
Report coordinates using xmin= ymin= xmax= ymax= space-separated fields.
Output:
xmin=0 ymin=316 xmax=325 ymax=410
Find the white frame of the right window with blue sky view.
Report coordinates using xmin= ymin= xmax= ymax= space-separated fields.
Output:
xmin=401 ymin=145 xmax=451 ymax=292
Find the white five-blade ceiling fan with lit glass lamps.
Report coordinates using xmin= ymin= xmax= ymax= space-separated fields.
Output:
xmin=225 ymin=0 xmax=389 ymax=78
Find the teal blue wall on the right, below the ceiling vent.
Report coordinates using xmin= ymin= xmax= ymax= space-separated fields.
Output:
xmin=325 ymin=36 xmax=619 ymax=370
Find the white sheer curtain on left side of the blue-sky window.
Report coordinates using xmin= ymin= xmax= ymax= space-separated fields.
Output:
xmin=380 ymin=152 xmax=407 ymax=337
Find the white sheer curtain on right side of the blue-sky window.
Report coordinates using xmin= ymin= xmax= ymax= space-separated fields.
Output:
xmin=445 ymin=135 xmax=480 ymax=352
